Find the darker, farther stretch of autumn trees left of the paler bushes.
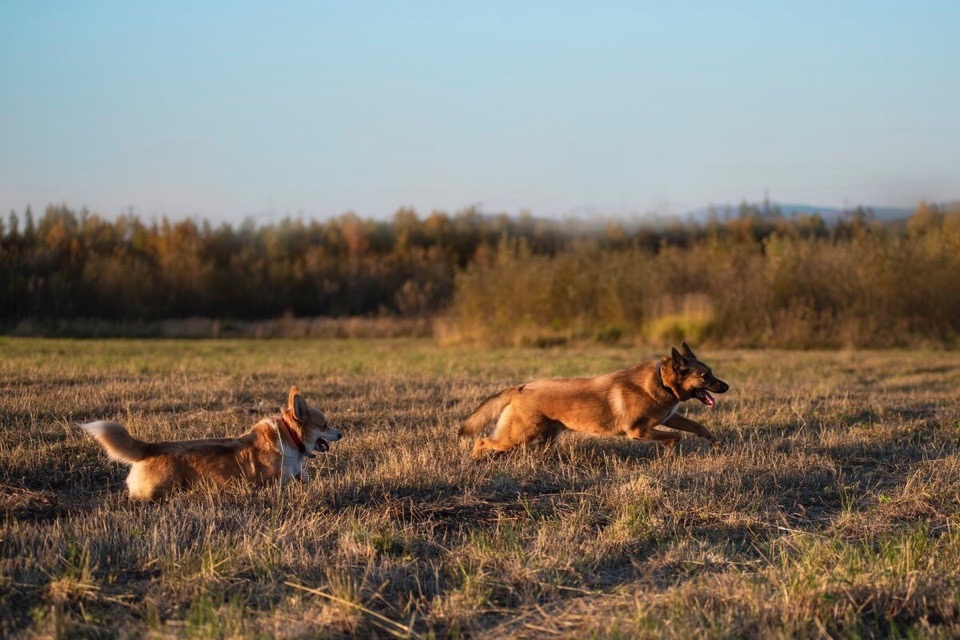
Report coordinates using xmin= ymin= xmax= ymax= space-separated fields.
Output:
xmin=0 ymin=205 xmax=536 ymax=322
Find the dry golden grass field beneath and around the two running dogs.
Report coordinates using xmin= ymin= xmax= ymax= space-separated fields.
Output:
xmin=0 ymin=338 xmax=960 ymax=639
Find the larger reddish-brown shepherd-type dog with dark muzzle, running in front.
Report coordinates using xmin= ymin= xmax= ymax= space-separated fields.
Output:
xmin=460 ymin=342 xmax=730 ymax=458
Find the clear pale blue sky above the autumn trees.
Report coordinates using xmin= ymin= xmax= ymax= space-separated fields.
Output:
xmin=0 ymin=0 xmax=960 ymax=221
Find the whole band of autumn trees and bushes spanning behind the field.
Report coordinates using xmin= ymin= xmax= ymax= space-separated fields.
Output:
xmin=0 ymin=203 xmax=960 ymax=347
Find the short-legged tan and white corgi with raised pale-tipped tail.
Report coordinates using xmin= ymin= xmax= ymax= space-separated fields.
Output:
xmin=81 ymin=387 xmax=341 ymax=500
